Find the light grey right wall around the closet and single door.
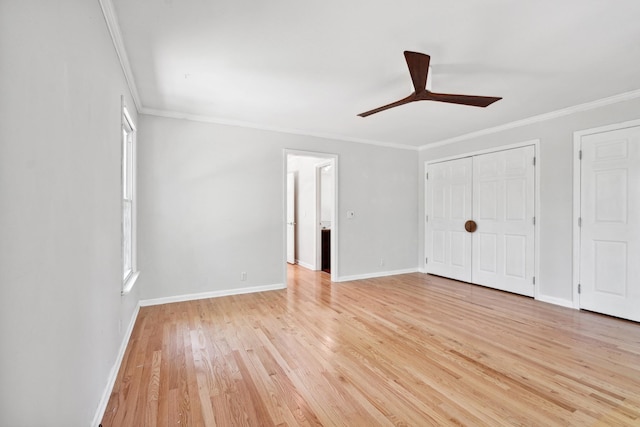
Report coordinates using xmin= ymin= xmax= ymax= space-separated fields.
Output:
xmin=418 ymin=99 xmax=640 ymax=305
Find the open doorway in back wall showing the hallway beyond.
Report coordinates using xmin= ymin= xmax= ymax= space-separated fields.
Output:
xmin=284 ymin=150 xmax=338 ymax=281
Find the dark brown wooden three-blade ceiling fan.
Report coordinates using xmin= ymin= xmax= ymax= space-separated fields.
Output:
xmin=358 ymin=50 xmax=502 ymax=117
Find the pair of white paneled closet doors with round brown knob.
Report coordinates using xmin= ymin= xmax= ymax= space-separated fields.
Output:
xmin=425 ymin=145 xmax=535 ymax=296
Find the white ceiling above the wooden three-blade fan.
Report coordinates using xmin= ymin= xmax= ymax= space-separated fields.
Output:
xmin=112 ymin=0 xmax=640 ymax=147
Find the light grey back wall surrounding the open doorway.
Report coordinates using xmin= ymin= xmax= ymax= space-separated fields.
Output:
xmin=138 ymin=115 xmax=418 ymax=299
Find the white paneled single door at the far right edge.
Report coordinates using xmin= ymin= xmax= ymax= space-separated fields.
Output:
xmin=579 ymin=126 xmax=640 ymax=321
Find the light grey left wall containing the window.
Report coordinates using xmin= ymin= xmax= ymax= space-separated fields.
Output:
xmin=0 ymin=0 xmax=139 ymax=427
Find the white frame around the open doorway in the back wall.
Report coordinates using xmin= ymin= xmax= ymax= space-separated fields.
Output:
xmin=282 ymin=148 xmax=340 ymax=286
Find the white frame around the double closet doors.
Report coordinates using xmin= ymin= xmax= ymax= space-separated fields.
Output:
xmin=421 ymin=139 xmax=544 ymax=300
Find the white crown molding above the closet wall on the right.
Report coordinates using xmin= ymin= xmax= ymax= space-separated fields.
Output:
xmin=418 ymin=89 xmax=640 ymax=151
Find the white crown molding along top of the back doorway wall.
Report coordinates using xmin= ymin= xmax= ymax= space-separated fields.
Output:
xmin=139 ymin=107 xmax=418 ymax=151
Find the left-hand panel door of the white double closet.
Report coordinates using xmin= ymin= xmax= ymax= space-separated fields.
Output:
xmin=425 ymin=157 xmax=473 ymax=282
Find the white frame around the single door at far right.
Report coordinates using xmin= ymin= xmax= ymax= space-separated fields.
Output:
xmin=572 ymin=119 xmax=640 ymax=310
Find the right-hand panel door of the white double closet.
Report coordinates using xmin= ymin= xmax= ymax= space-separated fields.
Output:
xmin=472 ymin=146 xmax=535 ymax=296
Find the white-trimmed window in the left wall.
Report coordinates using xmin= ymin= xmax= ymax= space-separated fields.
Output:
xmin=120 ymin=97 xmax=140 ymax=295
